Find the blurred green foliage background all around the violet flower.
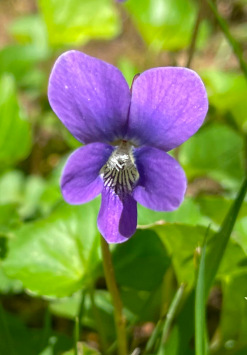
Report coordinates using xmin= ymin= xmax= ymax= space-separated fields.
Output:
xmin=0 ymin=0 xmax=247 ymax=355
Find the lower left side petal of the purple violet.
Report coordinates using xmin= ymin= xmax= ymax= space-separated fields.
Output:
xmin=61 ymin=143 xmax=113 ymax=205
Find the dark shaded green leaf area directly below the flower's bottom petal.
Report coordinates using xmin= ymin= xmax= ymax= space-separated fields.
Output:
xmin=112 ymin=230 xmax=170 ymax=291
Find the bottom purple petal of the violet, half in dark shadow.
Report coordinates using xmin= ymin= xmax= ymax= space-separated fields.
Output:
xmin=98 ymin=188 xmax=137 ymax=243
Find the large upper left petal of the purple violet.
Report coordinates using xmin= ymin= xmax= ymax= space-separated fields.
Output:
xmin=48 ymin=51 xmax=130 ymax=143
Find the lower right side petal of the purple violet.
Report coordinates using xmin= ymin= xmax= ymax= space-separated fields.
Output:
xmin=133 ymin=147 xmax=186 ymax=211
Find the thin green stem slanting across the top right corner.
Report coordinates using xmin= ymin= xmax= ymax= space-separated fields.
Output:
xmin=207 ymin=0 xmax=247 ymax=80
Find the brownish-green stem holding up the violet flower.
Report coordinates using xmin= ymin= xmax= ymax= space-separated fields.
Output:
xmin=101 ymin=236 xmax=127 ymax=355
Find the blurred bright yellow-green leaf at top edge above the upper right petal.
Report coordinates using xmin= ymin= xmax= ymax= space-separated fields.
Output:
xmin=126 ymin=0 xmax=207 ymax=51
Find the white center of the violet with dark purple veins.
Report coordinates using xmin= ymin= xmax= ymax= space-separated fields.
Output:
xmin=100 ymin=141 xmax=139 ymax=196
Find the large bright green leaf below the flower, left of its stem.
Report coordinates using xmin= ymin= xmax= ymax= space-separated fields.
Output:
xmin=3 ymin=200 xmax=99 ymax=297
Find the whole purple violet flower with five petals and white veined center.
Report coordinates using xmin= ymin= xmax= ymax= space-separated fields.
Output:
xmin=48 ymin=51 xmax=208 ymax=243
